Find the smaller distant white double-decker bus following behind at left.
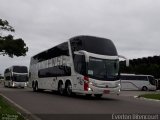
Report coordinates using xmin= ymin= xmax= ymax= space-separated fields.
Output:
xmin=4 ymin=66 xmax=28 ymax=88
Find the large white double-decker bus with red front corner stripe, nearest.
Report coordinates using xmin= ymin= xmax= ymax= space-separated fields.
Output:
xmin=29 ymin=36 xmax=126 ymax=97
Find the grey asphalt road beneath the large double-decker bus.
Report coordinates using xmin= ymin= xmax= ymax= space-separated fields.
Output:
xmin=0 ymin=85 xmax=160 ymax=120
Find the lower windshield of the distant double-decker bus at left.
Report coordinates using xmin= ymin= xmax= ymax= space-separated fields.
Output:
xmin=13 ymin=74 xmax=28 ymax=82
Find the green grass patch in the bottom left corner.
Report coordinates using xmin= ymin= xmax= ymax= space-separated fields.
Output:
xmin=0 ymin=96 xmax=25 ymax=120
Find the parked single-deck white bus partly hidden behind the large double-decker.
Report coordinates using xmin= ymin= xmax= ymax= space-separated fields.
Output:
xmin=120 ymin=74 xmax=156 ymax=91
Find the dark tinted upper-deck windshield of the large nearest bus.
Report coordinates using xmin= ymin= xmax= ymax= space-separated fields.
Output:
xmin=70 ymin=36 xmax=117 ymax=56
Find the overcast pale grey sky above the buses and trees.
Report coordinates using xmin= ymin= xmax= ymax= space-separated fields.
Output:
xmin=0 ymin=0 xmax=160 ymax=74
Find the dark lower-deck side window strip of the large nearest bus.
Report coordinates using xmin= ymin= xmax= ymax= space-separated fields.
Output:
xmin=38 ymin=66 xmax=71 ymax=78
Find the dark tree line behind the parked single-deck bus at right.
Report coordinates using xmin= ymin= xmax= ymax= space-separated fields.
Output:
xmin=120 ymin=56 xmax=160 ymax=78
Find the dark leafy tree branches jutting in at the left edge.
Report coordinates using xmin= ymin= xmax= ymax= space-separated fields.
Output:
xmin=0 ymin=19 xmax=28 ymax=57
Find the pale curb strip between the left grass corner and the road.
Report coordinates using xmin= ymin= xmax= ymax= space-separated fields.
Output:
xmin=0 ymin=93 xmax=42 ymax=120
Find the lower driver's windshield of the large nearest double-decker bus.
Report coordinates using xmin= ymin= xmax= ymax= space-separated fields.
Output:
xmin=87 ymin=57 xmax=119 ymax=81
